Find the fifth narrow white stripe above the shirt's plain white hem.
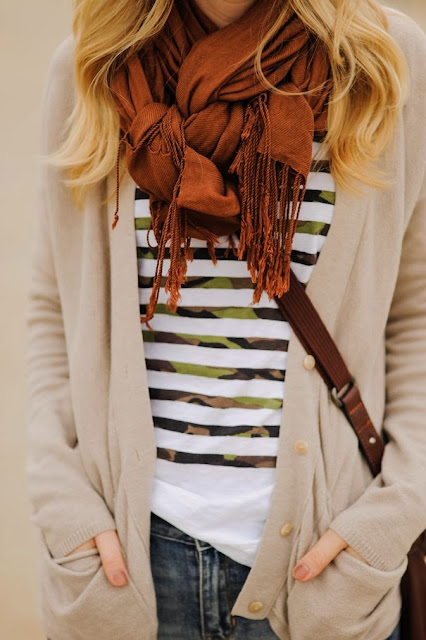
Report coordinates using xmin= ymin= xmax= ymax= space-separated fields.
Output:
xmin=141 ymin=313 xmax=291 ymax=340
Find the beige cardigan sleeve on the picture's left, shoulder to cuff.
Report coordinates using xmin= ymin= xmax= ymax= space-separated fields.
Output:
xmin=25 ymin=38 xmax=116 ymax=557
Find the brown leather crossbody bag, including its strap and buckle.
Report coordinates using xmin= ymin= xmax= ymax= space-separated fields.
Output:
xmin=275 ymin=271 xmax=426 ymax=640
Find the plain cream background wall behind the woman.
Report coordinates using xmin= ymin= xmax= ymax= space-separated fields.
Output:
xmin=0 ymin=0 xmax=426 ymax=640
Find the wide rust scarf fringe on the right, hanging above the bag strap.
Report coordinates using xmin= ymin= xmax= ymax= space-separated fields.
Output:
xmin=229 ymin=92 xmax=306 ymax=303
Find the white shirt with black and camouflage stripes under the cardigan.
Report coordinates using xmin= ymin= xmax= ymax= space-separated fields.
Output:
xmin=135 ymin=138 xmax=335 ymax=566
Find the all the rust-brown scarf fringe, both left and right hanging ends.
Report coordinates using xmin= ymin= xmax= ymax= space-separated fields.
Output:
xmin=140 ymin=92 xmax=306 ymax=329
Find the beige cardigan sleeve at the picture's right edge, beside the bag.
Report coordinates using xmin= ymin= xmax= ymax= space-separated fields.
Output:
xmin=330 ymin=166 xmax=426 ymax=570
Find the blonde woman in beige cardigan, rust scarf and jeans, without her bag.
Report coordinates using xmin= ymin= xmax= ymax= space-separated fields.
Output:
xmin=27 ymin=0 xmax=426 ymax=640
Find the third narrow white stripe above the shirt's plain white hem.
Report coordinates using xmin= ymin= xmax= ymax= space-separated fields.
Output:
xmin=147 ymin=369 xmax=285 ymax=400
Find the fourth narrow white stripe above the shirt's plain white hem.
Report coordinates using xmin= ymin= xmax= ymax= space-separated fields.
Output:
xmin=144 ymin=342 xmax=287 ymax=369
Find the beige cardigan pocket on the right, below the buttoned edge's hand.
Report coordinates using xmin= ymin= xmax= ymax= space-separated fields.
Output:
xmin=287 ymin=551 xmax=407 ymax=640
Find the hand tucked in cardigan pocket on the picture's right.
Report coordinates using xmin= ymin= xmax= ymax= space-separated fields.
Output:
xmin=293 ymin=529 xmax=368 ymax=582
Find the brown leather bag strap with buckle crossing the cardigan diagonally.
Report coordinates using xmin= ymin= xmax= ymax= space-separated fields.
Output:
xmin=275 ymin=270 xmax=384 ymax=475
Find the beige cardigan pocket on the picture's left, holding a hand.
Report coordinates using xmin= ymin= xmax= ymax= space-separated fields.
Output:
xmin=38 ymin=529 xmax=155 ymax=640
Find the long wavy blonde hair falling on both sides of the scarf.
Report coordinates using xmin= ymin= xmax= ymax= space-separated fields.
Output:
xmin=44 ymin=0 xmax=409 ymax=207
